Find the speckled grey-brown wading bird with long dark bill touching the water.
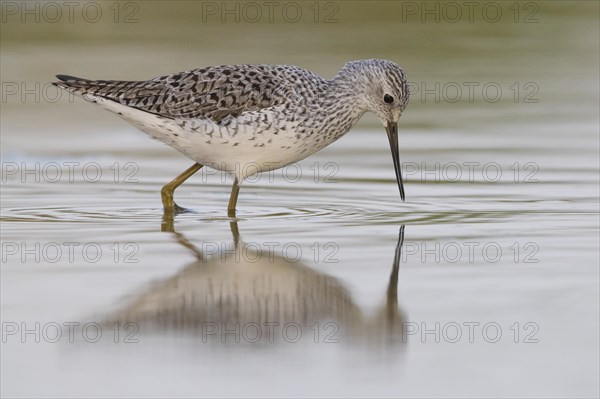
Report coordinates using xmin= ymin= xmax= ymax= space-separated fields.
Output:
xmin=54 ymin=59 xmax=409 ymax=217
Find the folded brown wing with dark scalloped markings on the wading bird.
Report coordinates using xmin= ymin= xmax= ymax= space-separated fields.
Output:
xmin=55 ymin=65 xmax=294 ymax=123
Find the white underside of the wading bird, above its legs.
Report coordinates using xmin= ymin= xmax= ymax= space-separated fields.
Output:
xmin=93 ymin=95 xmax=336 ymax=182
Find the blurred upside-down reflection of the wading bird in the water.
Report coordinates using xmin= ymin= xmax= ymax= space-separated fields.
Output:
xmin=106 ymin=216 xmax=405 ymax=343
